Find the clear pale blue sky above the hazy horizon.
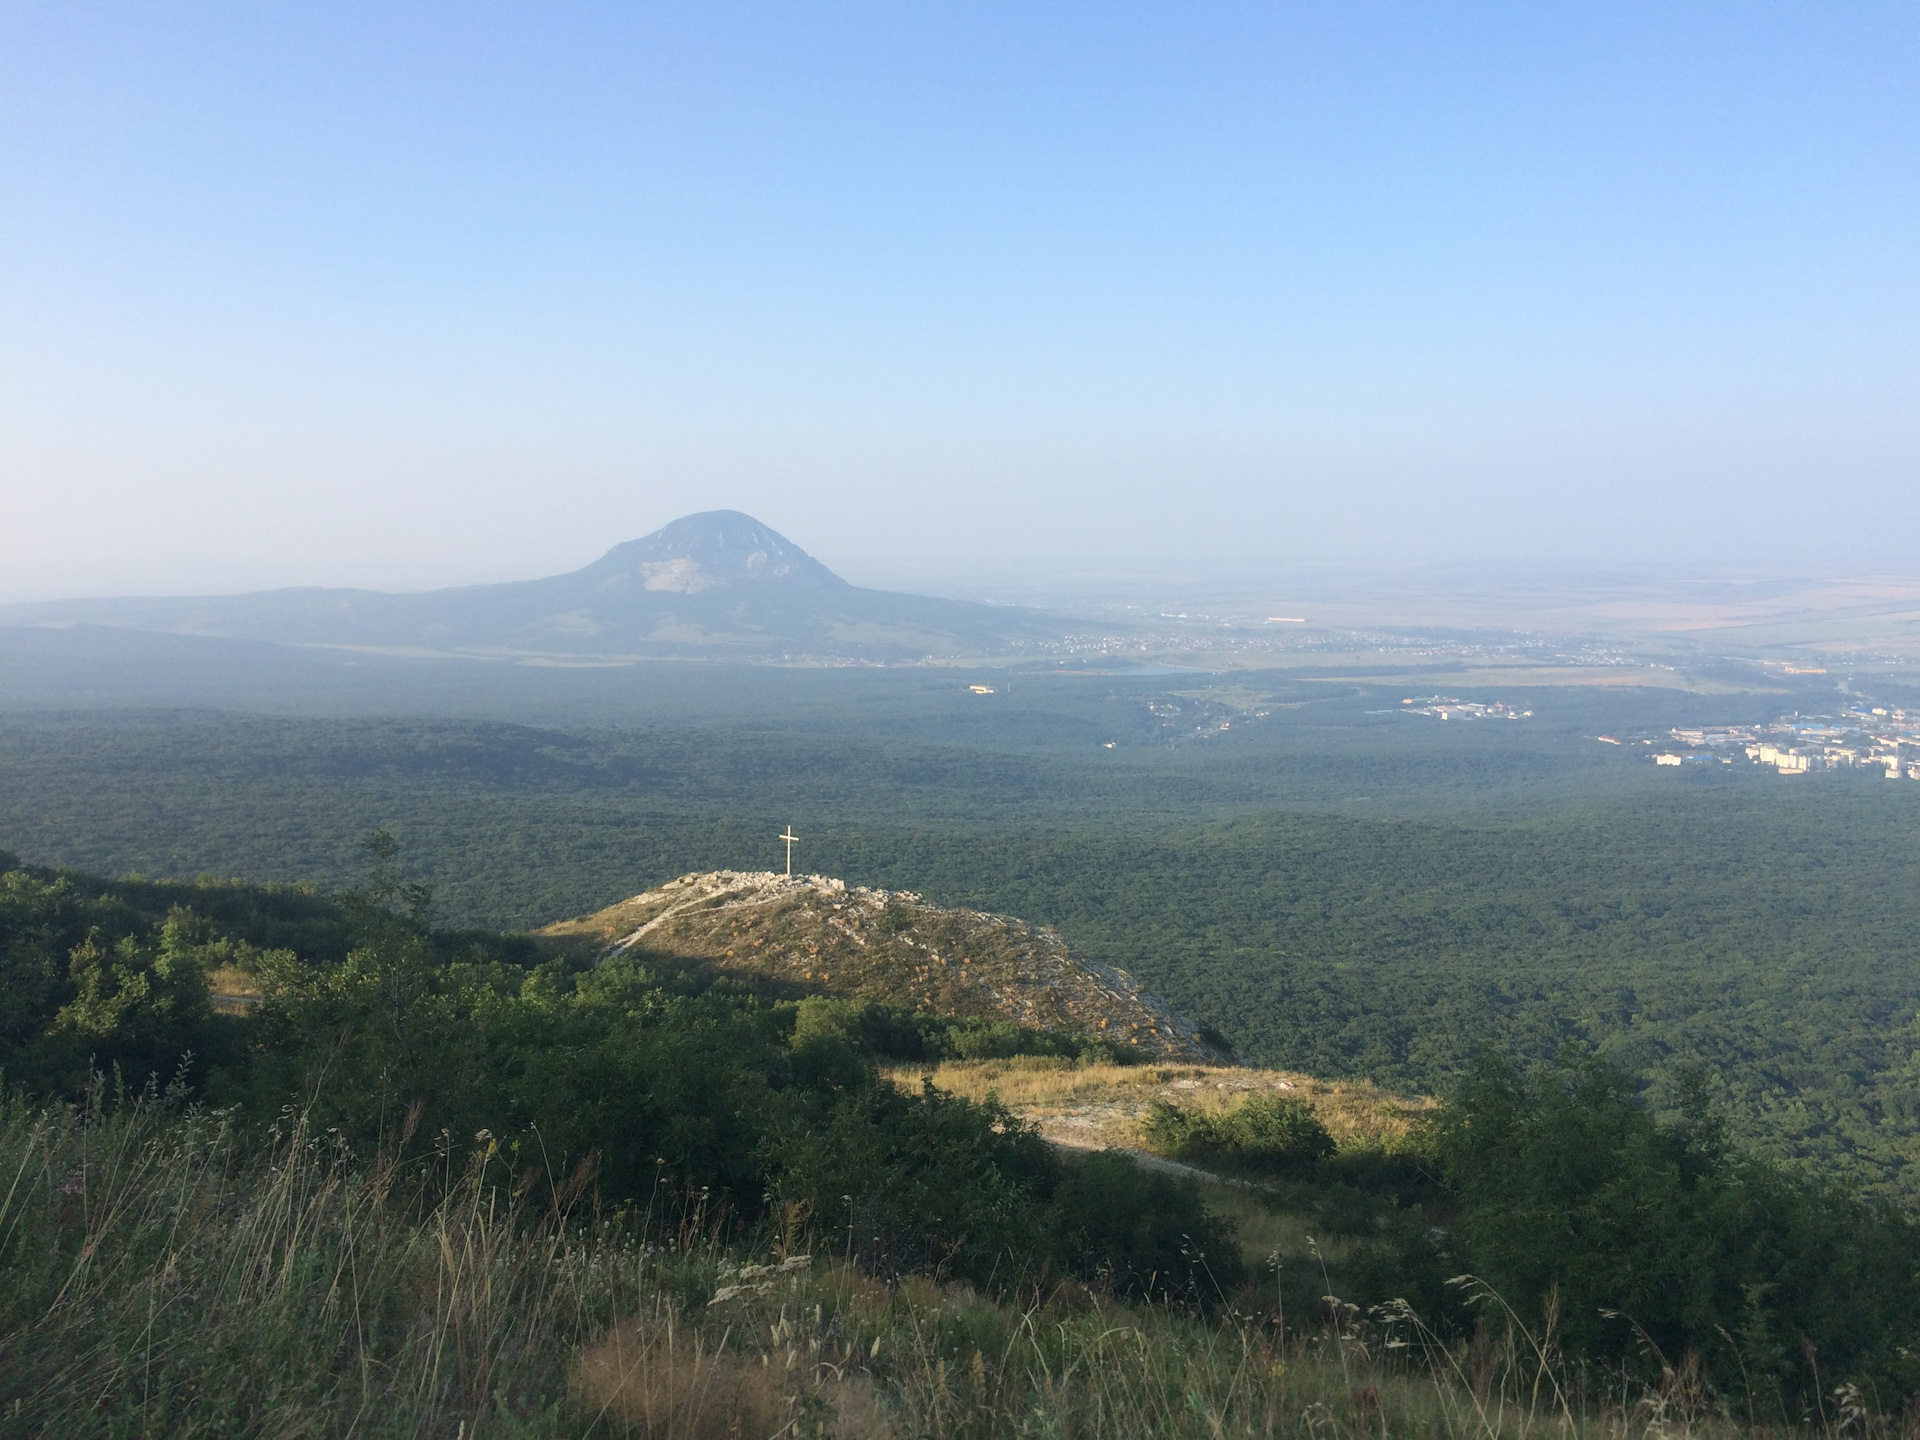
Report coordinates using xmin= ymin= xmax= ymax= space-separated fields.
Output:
xmin=0 ymin=0 xmax=1920 ymax=599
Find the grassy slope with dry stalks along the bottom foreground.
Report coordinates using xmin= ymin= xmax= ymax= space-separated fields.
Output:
xmin=0 ymin=1100 xmax=1873 ymax=1440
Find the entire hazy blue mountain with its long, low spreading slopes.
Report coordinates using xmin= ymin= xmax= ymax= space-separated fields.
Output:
xmin=0 ymin=511 xmax=1056 ymax=659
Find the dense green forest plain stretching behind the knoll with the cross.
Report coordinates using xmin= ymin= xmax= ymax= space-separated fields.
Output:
xmin=0 ymin=672 xmax=1920 ymax=1204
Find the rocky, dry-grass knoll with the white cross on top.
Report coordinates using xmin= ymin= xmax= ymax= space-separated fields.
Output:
xmin=538 ymin=870 xmax=1229 ymax=1064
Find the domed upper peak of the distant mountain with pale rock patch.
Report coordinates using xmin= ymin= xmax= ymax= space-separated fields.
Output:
xmin=580 ymin=511 xmax=849 ymax=595
